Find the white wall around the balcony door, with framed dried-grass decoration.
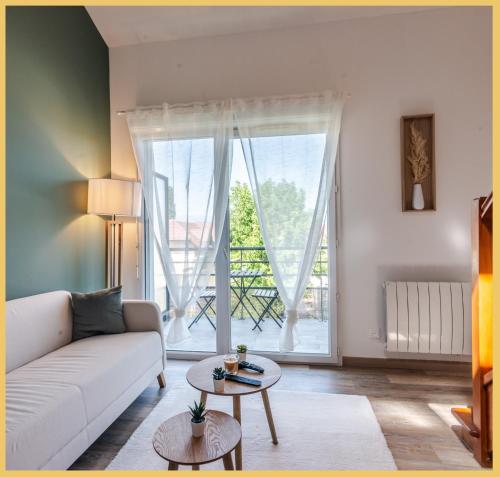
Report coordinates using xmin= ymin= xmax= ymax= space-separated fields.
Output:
xmin=110 ymin=7 xmax=491 ymax=357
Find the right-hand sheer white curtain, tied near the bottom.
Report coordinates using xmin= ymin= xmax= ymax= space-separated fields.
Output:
xmin=232 ymin=92 xmax=343 ymax=352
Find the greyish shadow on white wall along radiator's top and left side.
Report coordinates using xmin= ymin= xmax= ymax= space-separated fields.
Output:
xmin=377 ymin=264 xmax=471 ymax=341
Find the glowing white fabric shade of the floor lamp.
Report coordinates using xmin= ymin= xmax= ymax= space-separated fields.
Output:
xmin=87 ymin=179 xmax=141 ymax=217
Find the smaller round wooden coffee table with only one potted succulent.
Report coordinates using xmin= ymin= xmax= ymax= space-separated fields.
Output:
xmin=153 ymin=411 xmax=241 ymax=470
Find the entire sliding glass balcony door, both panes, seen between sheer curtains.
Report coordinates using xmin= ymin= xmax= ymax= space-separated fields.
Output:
xmin=145 ymin=139 xmax=337 ymax=363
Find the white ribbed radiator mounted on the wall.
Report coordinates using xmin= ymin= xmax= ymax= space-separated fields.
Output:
xmin=385 ymin=282 xmax=471 ymax=355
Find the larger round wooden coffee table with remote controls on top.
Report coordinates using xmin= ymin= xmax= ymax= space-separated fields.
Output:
xmin=186 ymin=354 xmax=281 ymax=470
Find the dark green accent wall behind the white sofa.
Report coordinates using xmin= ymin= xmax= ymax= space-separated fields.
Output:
xmin=6 ymin=7 xmax=111 ymax=300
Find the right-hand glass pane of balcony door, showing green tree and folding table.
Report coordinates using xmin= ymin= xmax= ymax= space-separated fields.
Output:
xmin=229 ymin=141 xmax=330 ymax=356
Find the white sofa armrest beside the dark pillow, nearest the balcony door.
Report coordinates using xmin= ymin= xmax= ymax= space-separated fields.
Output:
xmin=123 ymin=300 xmax=167 ymax=368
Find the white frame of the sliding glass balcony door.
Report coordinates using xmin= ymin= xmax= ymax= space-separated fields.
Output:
xmin=143 ymin=156 xmax=342 ymax=366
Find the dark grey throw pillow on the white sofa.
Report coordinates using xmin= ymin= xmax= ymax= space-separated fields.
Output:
xmin=71 ymin=286 xmax=126 ymax=341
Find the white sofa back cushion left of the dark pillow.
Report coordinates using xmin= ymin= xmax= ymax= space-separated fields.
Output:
xmin=5 ymin=291 xmax=72 ymax=372
